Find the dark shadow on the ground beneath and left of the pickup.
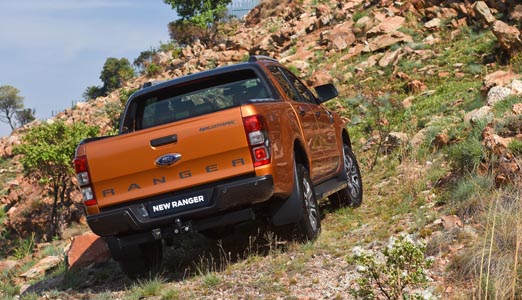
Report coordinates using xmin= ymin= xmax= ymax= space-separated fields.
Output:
xmin=22 ymin=201 xmax=339 ymax=295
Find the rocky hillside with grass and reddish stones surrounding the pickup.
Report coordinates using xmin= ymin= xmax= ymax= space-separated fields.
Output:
xmin=0 ymin=0 xmax=522 ymax=299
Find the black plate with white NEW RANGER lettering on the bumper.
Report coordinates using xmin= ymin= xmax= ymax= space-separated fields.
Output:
xmin=147 ymin=193 xmax=210 ymax=218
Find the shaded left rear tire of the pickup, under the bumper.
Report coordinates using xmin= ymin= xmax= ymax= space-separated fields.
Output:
xmin=118 ymin=240 xmax=163 ymax=279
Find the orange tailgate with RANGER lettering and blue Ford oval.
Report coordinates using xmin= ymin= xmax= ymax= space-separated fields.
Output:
xmin=86 ymin=107 xmax=254 ymax=208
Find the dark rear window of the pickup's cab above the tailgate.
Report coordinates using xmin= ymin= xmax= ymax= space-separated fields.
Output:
xmin=123 ymin=70 xmax=269 ymax=132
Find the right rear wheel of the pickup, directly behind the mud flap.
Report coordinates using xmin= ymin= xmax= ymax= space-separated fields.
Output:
xmin=295 ymin=164 xmax=321 ymax=242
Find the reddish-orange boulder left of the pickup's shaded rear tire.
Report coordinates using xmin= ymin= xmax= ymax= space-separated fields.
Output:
xmin=67 ymin=232 xmax=110 ymax=269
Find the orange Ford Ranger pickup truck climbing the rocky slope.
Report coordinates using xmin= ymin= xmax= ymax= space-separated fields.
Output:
xmin=74 ymin=56 xmax=362 ymax=275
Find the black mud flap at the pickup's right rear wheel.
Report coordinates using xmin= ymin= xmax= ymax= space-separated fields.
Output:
xmin=272 ymin=161 xmax=304 ymax=226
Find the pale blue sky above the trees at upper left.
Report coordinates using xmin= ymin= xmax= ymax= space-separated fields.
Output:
xmin=0 ymin=0 xmax=176 ymax=136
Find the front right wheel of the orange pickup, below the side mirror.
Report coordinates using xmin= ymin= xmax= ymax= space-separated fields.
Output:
xmin=328 ymin=144 xmax=363 ymax=207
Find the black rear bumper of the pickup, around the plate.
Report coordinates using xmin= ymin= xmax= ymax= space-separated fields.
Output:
xmin=87 ymin=175 xmax=274 ymax=239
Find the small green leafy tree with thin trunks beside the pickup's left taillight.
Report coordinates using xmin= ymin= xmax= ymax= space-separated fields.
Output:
xmin=14 ymin=122 xmax=99 ymax=240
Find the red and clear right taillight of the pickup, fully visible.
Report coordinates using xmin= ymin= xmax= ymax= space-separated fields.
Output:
xmin=243 ymin=115 xmax=270 ymax=167
